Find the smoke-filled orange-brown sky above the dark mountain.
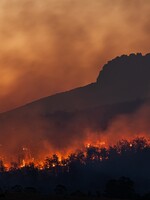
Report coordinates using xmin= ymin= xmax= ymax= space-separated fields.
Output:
xmin=0 ymin=0 xmax=150 ymax=112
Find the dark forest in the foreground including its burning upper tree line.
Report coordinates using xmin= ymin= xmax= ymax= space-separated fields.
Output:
xmin=0 ymin=137 xmax=150 ymax=199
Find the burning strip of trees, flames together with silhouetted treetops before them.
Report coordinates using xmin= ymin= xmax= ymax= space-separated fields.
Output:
xmin=0 ymin=137 xmax=150 ymax=174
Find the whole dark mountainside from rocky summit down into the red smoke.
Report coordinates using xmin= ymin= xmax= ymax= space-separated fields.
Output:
xmin=0 ymin=53 xmax=150 ymax=159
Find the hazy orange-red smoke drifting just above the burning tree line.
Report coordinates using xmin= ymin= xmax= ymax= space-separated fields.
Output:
xmin=0 ymin=101 xmax=150 ymax=169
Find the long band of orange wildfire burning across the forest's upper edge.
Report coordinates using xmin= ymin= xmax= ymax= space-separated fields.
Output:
xmin=0 ymin=137 xmax=150 ymax=171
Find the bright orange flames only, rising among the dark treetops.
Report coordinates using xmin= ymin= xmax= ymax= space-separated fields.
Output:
xmin=0 ymin=134 xmax=150 ymax=171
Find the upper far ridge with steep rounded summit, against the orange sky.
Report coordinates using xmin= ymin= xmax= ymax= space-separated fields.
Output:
xmin=2 ymin=53 xmax=150 ymax=113
